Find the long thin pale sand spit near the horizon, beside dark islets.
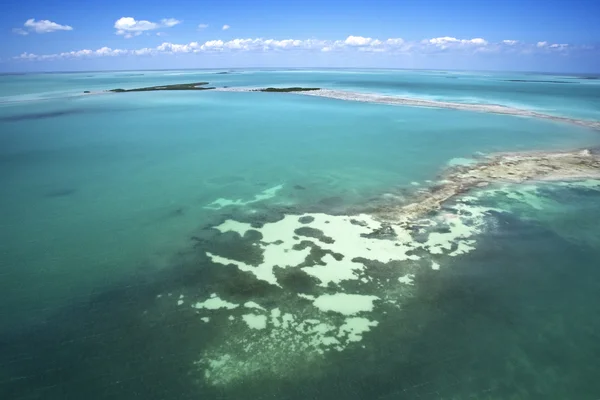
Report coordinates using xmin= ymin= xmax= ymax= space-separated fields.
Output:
xmin=215 ymin=88 xmax=600 ymax=130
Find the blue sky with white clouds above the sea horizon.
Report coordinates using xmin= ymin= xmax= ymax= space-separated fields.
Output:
xmin=0 ymin=0 xmax=600 ymax=73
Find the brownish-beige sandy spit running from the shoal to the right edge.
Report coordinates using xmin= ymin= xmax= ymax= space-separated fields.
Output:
xmin=377 ymin=150 xmax=600 ymax=220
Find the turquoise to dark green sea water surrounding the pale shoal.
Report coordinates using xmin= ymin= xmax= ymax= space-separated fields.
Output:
xmin=0 ymin=70 xmax=600 ymax=399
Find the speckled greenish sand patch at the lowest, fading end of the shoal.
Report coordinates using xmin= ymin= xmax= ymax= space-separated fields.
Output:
xmin=202 ymin=309 xmax=377 ymax=386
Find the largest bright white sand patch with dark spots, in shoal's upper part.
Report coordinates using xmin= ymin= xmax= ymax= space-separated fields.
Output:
xmin=207 ymin=208 xmax=488 ymax=287
